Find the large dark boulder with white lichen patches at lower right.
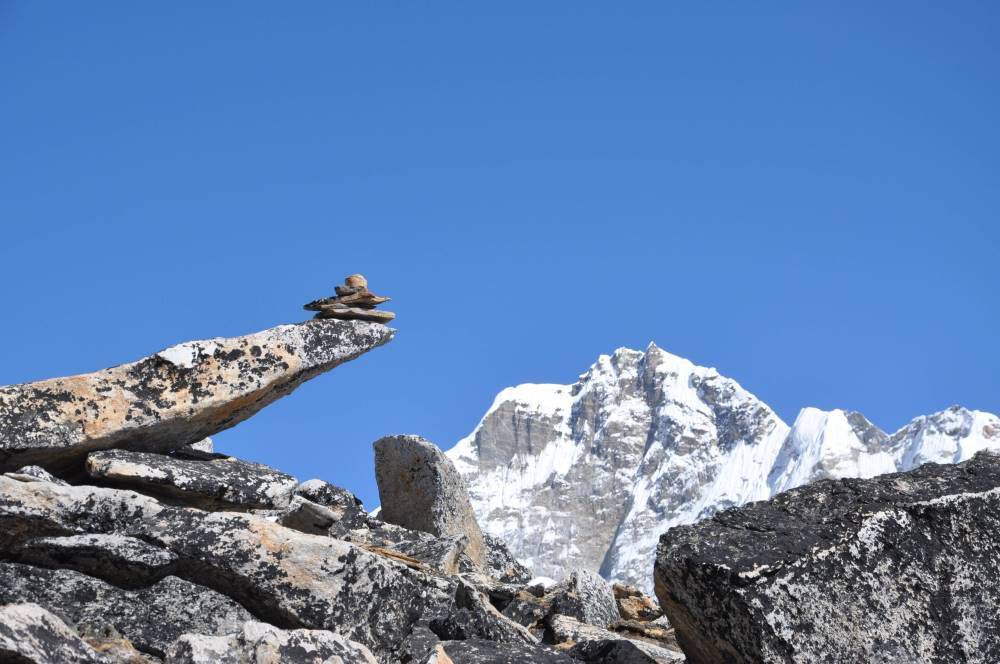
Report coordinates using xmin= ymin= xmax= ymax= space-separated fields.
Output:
xmin=655 ymin=452 xmax=1000 ymax=664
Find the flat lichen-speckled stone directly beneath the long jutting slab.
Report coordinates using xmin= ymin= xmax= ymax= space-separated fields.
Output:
xmin=87 ymin=450 xmax=298 ymax=509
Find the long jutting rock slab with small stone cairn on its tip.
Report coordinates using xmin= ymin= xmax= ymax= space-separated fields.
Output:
xmin=0 ymin=320 xmax=394 ymax=472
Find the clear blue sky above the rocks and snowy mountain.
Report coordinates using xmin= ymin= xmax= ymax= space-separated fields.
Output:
xmin=0 ymin=0 xmax=1000 ymax=504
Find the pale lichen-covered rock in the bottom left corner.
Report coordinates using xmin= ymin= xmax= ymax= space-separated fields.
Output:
xmin=0 ymin=603 xmax=112 ymax=664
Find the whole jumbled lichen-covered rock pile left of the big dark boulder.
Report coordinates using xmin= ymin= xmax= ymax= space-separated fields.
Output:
xmin=0 ymin=320 xmax=680 ymax=664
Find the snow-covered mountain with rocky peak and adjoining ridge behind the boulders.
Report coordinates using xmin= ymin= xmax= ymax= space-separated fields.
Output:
xmin=448 ymin=344 xmax=1000 ymax=589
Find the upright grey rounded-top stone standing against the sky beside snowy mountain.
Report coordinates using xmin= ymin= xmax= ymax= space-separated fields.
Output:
xmin=374 ymin=436 xmax=486 ymax=566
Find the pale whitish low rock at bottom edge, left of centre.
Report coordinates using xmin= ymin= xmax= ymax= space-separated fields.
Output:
xmin=166 ymin=622 xmax=378 ymax=664
